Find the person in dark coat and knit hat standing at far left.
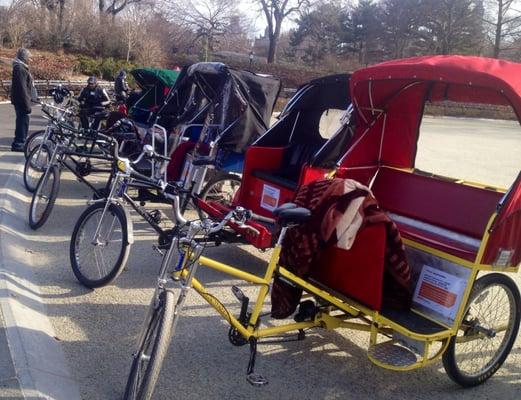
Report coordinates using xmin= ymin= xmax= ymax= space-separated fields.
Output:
xmin=11 ymin=48 xmax=37 ymax=151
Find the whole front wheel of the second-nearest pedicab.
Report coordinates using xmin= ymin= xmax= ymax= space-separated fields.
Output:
xmin=69 ymin=202 xmax=130 ymax=288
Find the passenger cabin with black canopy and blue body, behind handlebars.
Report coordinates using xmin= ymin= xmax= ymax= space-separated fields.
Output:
xmin=161 ymin=63 xmax=281 ymax=208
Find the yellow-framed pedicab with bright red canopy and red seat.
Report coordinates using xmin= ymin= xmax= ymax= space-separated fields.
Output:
xmin=125 ymin=56 xmax=521 ymax=399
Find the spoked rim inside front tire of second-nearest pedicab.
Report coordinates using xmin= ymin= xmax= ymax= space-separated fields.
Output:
xmin=74 ymin=207 xmax=125 ymax=281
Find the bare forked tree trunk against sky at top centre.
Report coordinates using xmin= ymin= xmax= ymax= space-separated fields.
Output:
xmin=253 ymin=0 xmax=310 ymax=63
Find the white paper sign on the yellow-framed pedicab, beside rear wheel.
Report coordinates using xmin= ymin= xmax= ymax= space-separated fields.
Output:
xmin=413 ymin=265 xmax=467 ymax=323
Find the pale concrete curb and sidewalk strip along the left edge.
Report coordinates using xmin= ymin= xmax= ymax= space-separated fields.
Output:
xmin=0 ymin=106 xmax=80 ymax=400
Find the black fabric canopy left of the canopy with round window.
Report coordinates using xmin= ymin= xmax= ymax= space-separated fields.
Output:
xmin=161 ymin=63 xmax=281 ymax=153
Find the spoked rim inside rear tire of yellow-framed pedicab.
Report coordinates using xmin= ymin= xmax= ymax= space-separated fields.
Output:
xmin=448 ymin=283 xmax=516 ymax=378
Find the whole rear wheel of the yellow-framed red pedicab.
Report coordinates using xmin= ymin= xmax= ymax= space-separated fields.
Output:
xmin=443 ymin=273 xmax=521 ymax=387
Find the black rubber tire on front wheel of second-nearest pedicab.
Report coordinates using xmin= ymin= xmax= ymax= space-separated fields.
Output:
xmin=69 ymin=202 xmax=130 ymax=289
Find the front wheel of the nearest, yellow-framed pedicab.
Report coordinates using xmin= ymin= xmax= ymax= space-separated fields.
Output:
xmin=123 ymin=290 xmax=174 ymax=400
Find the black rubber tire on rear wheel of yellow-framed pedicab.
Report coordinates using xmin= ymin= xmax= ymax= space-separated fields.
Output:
xmin=443 ymin=273 xmax=521 ymax=387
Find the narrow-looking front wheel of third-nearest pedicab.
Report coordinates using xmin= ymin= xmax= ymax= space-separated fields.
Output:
xmin=29 ymin=165 xmax=60 ymax=229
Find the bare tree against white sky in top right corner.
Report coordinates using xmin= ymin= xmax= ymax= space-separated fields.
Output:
xmin=484 ymin=0 xmax=521 ymax=58
